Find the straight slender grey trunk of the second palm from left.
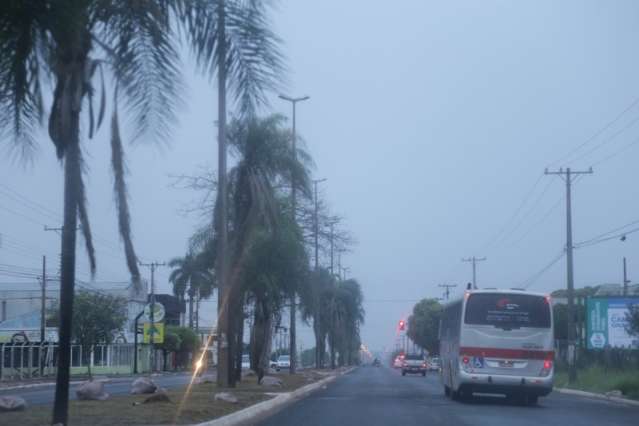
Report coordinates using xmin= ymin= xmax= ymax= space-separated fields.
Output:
xmin=213 ymin=0 xmax=233 ymax=387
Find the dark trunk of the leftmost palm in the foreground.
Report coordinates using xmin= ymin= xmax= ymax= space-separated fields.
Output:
xmin=52 ymin=89 xmax=82 ymax=425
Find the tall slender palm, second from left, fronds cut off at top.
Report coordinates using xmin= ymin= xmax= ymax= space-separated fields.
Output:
xmin=184 ymin=0 xmax=283 ymax=387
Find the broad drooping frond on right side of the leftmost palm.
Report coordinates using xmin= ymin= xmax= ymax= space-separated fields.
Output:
xmin=99 ymin=0 xmax=183 ymax=141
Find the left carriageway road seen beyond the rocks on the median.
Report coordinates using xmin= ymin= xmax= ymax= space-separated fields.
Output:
xmin=0 ymin=374 xmax=191 ymax=405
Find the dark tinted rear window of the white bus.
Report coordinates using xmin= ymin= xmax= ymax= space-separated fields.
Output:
xmin=464 ymin=293 xmax=550 ymax=329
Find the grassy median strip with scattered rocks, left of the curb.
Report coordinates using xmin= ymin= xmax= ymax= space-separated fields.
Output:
xmin=0 ymin=368 xmax=319 ymax=426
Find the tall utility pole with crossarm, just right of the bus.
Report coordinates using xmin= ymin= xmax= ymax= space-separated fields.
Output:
xmin=544 ymin=167 xmax=592 ymax=383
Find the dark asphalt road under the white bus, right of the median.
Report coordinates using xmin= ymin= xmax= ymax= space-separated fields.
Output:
xmin=260 ymin=367 xmax=639 ymax=426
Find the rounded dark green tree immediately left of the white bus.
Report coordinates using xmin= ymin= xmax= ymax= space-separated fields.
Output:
xmin=407 ymin=299 xmax=442 ymax=354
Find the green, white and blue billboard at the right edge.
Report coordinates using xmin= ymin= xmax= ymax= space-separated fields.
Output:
xmin=586 ymin=296 xmax=639 ymax=349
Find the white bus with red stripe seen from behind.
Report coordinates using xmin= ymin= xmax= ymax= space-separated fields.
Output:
xmin=439 ymin=289 xmax=554 ymax=404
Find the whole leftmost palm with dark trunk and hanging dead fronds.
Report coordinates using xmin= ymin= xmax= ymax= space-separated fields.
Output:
xmin=0 ymin=0 xmax=192 ymax=424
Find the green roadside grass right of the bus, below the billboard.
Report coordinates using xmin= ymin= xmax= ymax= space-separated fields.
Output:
xmin=555 ymin=366 xmax=639 ymax=399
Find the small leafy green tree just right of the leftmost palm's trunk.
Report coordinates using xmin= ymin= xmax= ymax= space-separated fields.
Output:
xmin=49 ymin=290 xmax=127 ymax=377
